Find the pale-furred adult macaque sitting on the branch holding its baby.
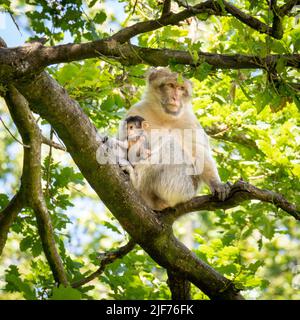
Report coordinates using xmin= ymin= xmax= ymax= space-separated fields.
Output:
xmin=121 ymin=68 xmax=230 ymax=210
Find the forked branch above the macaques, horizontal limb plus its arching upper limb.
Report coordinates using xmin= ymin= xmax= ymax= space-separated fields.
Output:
xmin=0 ymin=0 xmax=300 ymax=81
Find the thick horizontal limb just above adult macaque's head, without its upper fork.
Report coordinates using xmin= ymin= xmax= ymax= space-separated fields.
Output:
xmin=0 ymin=40 xmax=300 ymax=83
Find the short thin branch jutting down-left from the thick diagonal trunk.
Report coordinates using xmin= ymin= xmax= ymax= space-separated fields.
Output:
xmin=71 ymin=239 xmax=136 ymax=288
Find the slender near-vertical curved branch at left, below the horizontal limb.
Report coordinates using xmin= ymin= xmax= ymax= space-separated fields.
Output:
xmin=5 ymin=85 xmax=68 ymax=285
